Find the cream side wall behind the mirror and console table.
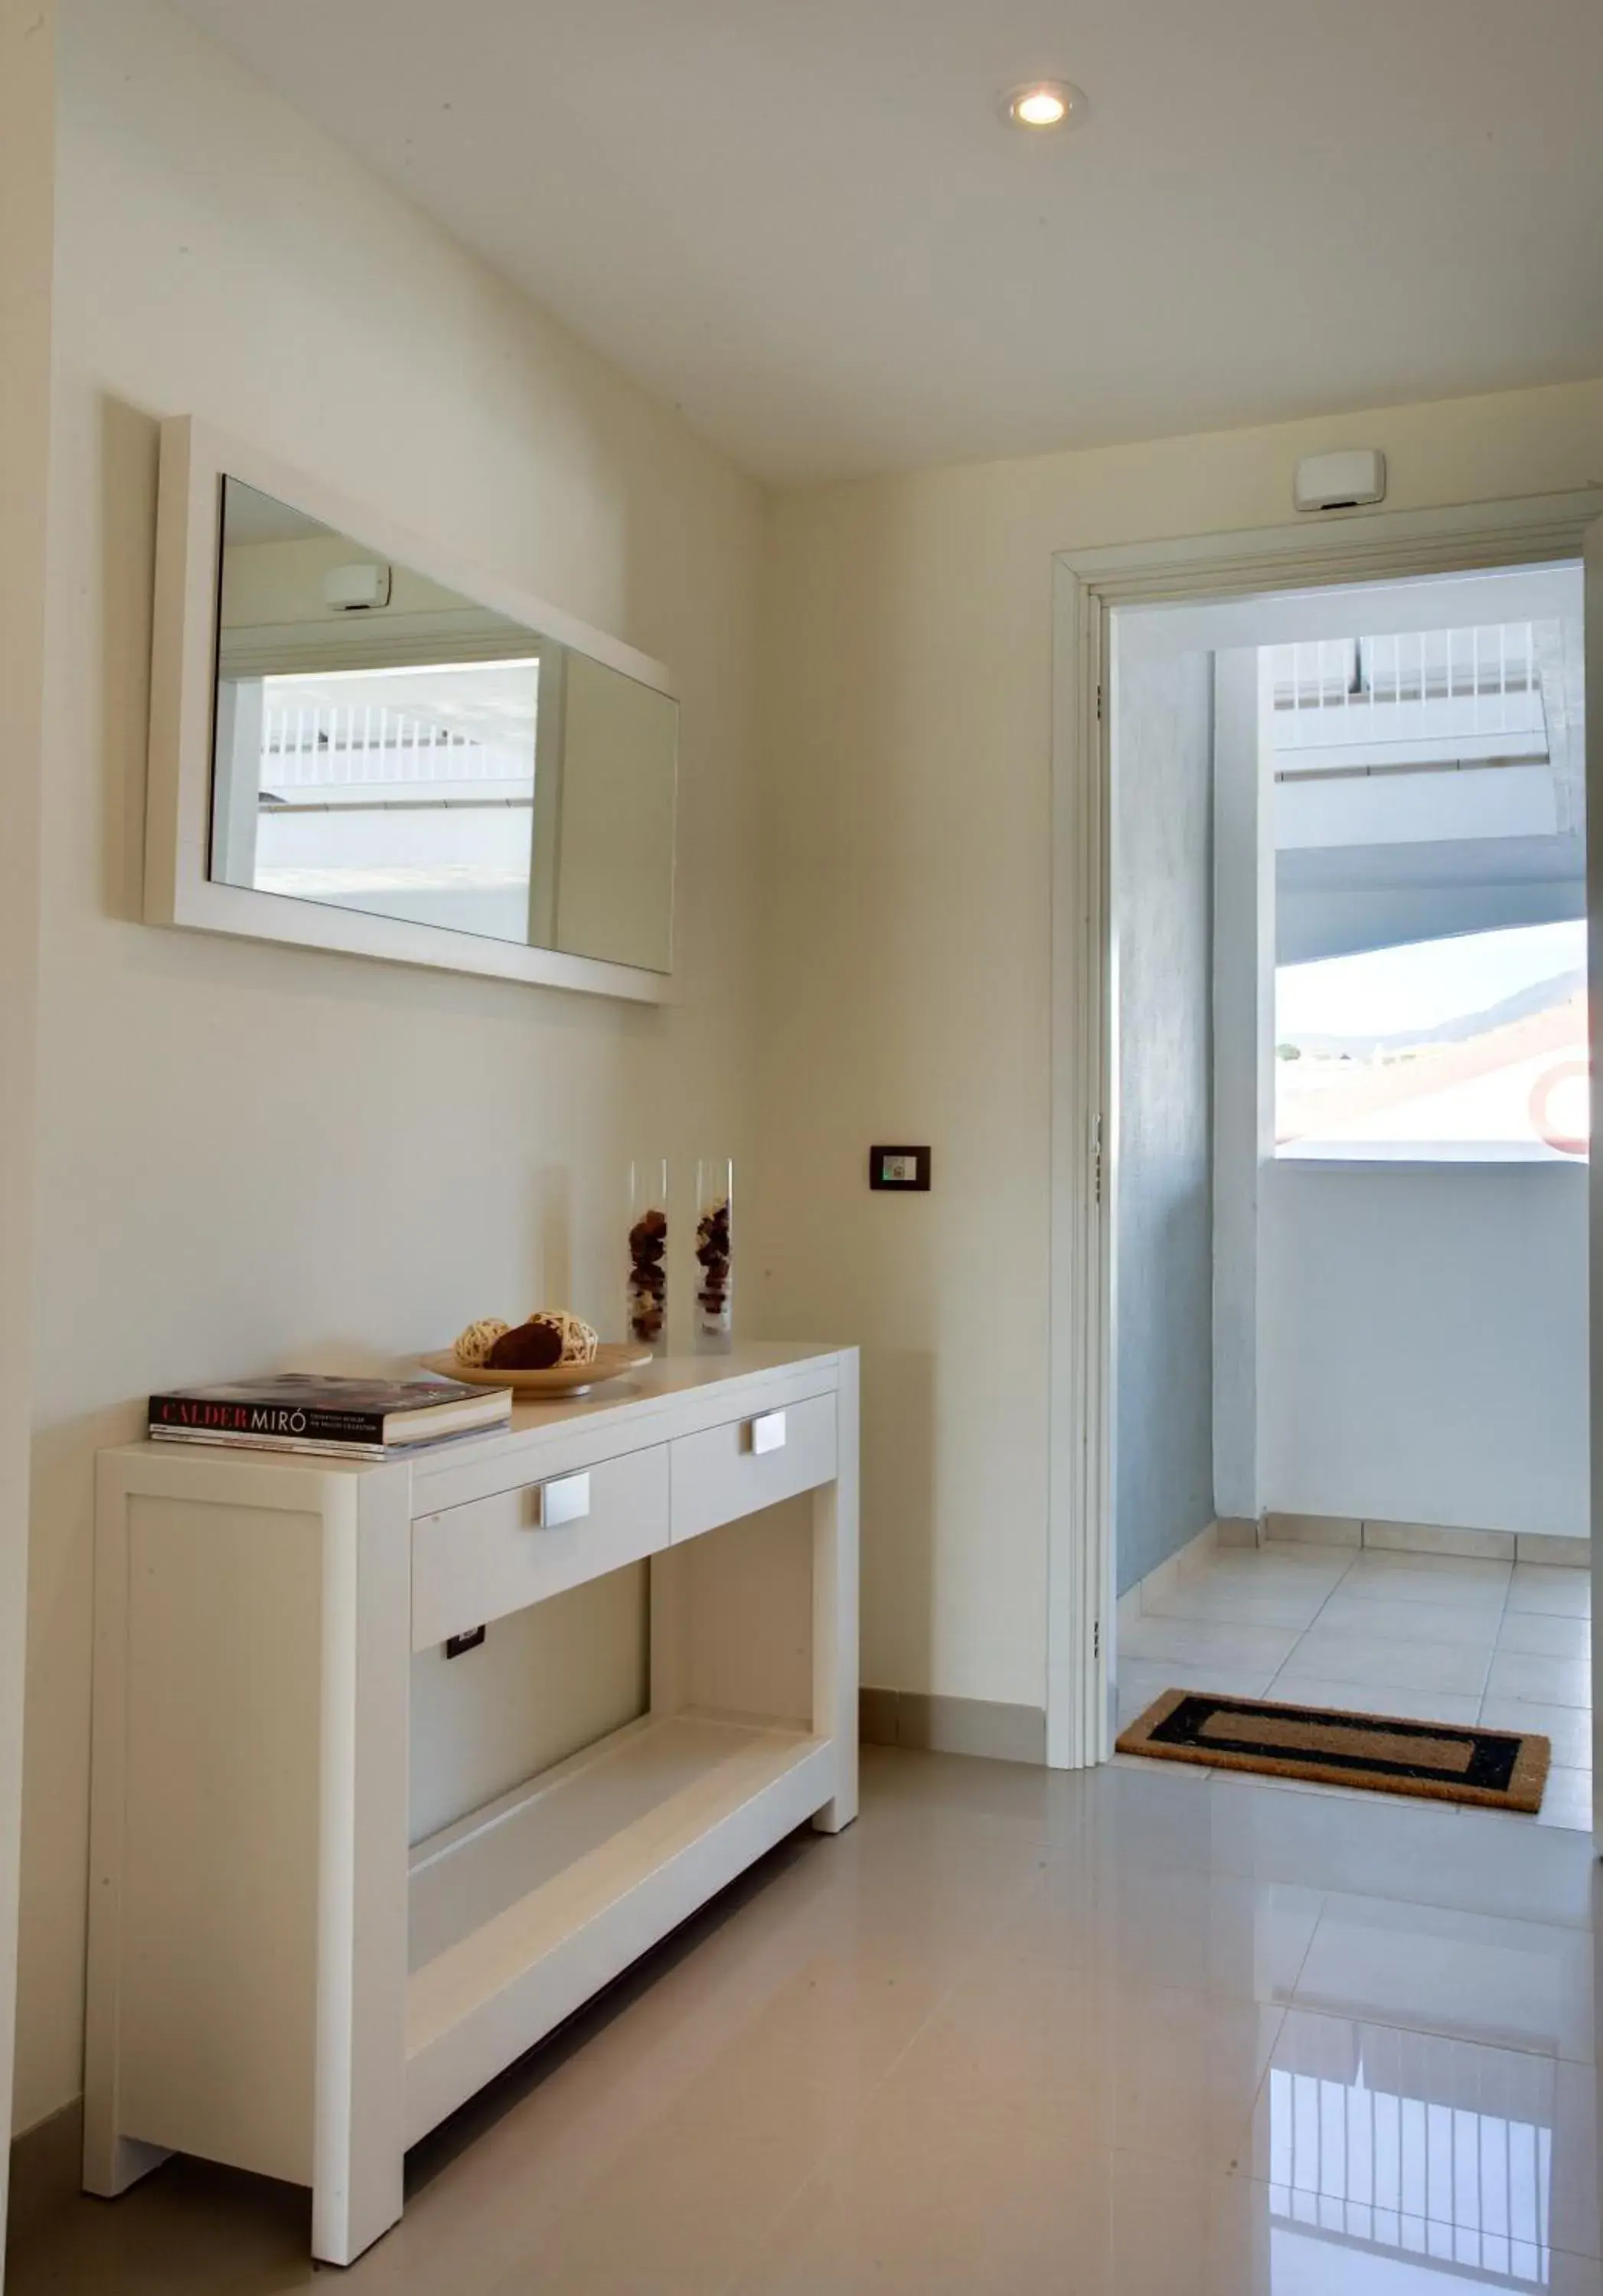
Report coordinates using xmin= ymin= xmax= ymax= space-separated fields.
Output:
xmin=18 ymin=0 xmax=765 ymax=2126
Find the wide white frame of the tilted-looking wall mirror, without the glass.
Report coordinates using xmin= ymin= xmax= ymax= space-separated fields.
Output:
xmin=145 ymin=416 xmax=677 ymax=1003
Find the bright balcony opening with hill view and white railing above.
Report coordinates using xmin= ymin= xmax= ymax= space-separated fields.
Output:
xmin=1270 ymin=622 xmax=1592 ymax=1162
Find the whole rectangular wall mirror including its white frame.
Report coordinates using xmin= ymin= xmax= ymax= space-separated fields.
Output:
xmin=147 ymin=422 xmax=677 ymax=1001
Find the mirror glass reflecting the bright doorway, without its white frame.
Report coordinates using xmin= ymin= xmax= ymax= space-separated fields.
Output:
xmin=211 ymin=478 xmax=677 ymax=971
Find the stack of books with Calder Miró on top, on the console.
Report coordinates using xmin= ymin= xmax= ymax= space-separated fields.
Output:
xmin=149 ymin=1371 xmax=512 ymax=1458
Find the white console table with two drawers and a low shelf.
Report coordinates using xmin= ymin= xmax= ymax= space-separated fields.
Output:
xmin=85 ymin=1348 xmax=857 ymax=2264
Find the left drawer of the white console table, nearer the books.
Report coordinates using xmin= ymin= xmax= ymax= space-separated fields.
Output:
xmin=411 ymin=1444 xmax=668 ymax=1651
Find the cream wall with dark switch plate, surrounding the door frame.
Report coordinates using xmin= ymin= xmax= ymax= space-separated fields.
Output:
xmin=762 ymin=383 xmax=1603 ymax=1706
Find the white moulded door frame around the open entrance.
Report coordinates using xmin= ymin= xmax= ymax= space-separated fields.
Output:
xmin=1047 ymin=487 xmax=1603 ymax=1770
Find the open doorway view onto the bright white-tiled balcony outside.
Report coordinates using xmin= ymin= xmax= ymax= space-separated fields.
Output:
xmin=1109 ymin=565 xmax=1592 ymax=1825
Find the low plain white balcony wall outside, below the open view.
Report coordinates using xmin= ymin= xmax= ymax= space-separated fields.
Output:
xmin=1261 ymin=1162 xmax=1589 ymax=1536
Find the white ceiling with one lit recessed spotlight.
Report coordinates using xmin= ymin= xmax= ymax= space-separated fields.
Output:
xmin=179 ymin=0 xmax=1603 ymax=480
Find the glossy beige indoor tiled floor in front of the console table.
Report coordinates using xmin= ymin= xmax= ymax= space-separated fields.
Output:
xmin=7 ymin=1745 xmax=1603 ymax=2296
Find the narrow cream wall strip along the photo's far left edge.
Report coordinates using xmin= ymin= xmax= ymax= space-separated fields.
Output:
xmin=0 ymin=0 xmax=55 ymax=2223
